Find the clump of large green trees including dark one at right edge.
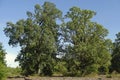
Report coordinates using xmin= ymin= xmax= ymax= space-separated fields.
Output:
xmin=0 ymin=2 xmax=120 ymax=76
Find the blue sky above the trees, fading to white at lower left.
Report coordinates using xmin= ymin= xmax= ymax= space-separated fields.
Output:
xmin=0 ymin=0 xmax=120 ymax=67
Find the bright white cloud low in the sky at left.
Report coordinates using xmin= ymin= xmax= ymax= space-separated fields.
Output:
xmin=6 ymin=53 xmax=18 ymax=67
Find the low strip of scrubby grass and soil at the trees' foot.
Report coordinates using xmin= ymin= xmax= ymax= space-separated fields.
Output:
xmin=7 ymin=68 xmax=120 ymax=80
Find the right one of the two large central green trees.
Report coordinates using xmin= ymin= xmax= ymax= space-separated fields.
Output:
xmin=65 ymin=7 xmax=111 ymax=76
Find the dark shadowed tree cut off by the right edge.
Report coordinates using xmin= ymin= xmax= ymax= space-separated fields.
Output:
xmin=111 ymin=32 xmax=120 ymax=73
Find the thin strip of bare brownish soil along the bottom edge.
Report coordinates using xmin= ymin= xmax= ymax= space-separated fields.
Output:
xmin=7 ymin=77 xmax=120 ymax=80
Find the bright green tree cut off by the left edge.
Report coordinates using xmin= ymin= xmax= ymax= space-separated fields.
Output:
xmin=0 ymin=43 xmax=6 ymax=80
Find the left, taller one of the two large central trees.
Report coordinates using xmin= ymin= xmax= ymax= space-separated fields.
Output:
xmin=4 ymin=2 xmax=62 ymax=75
